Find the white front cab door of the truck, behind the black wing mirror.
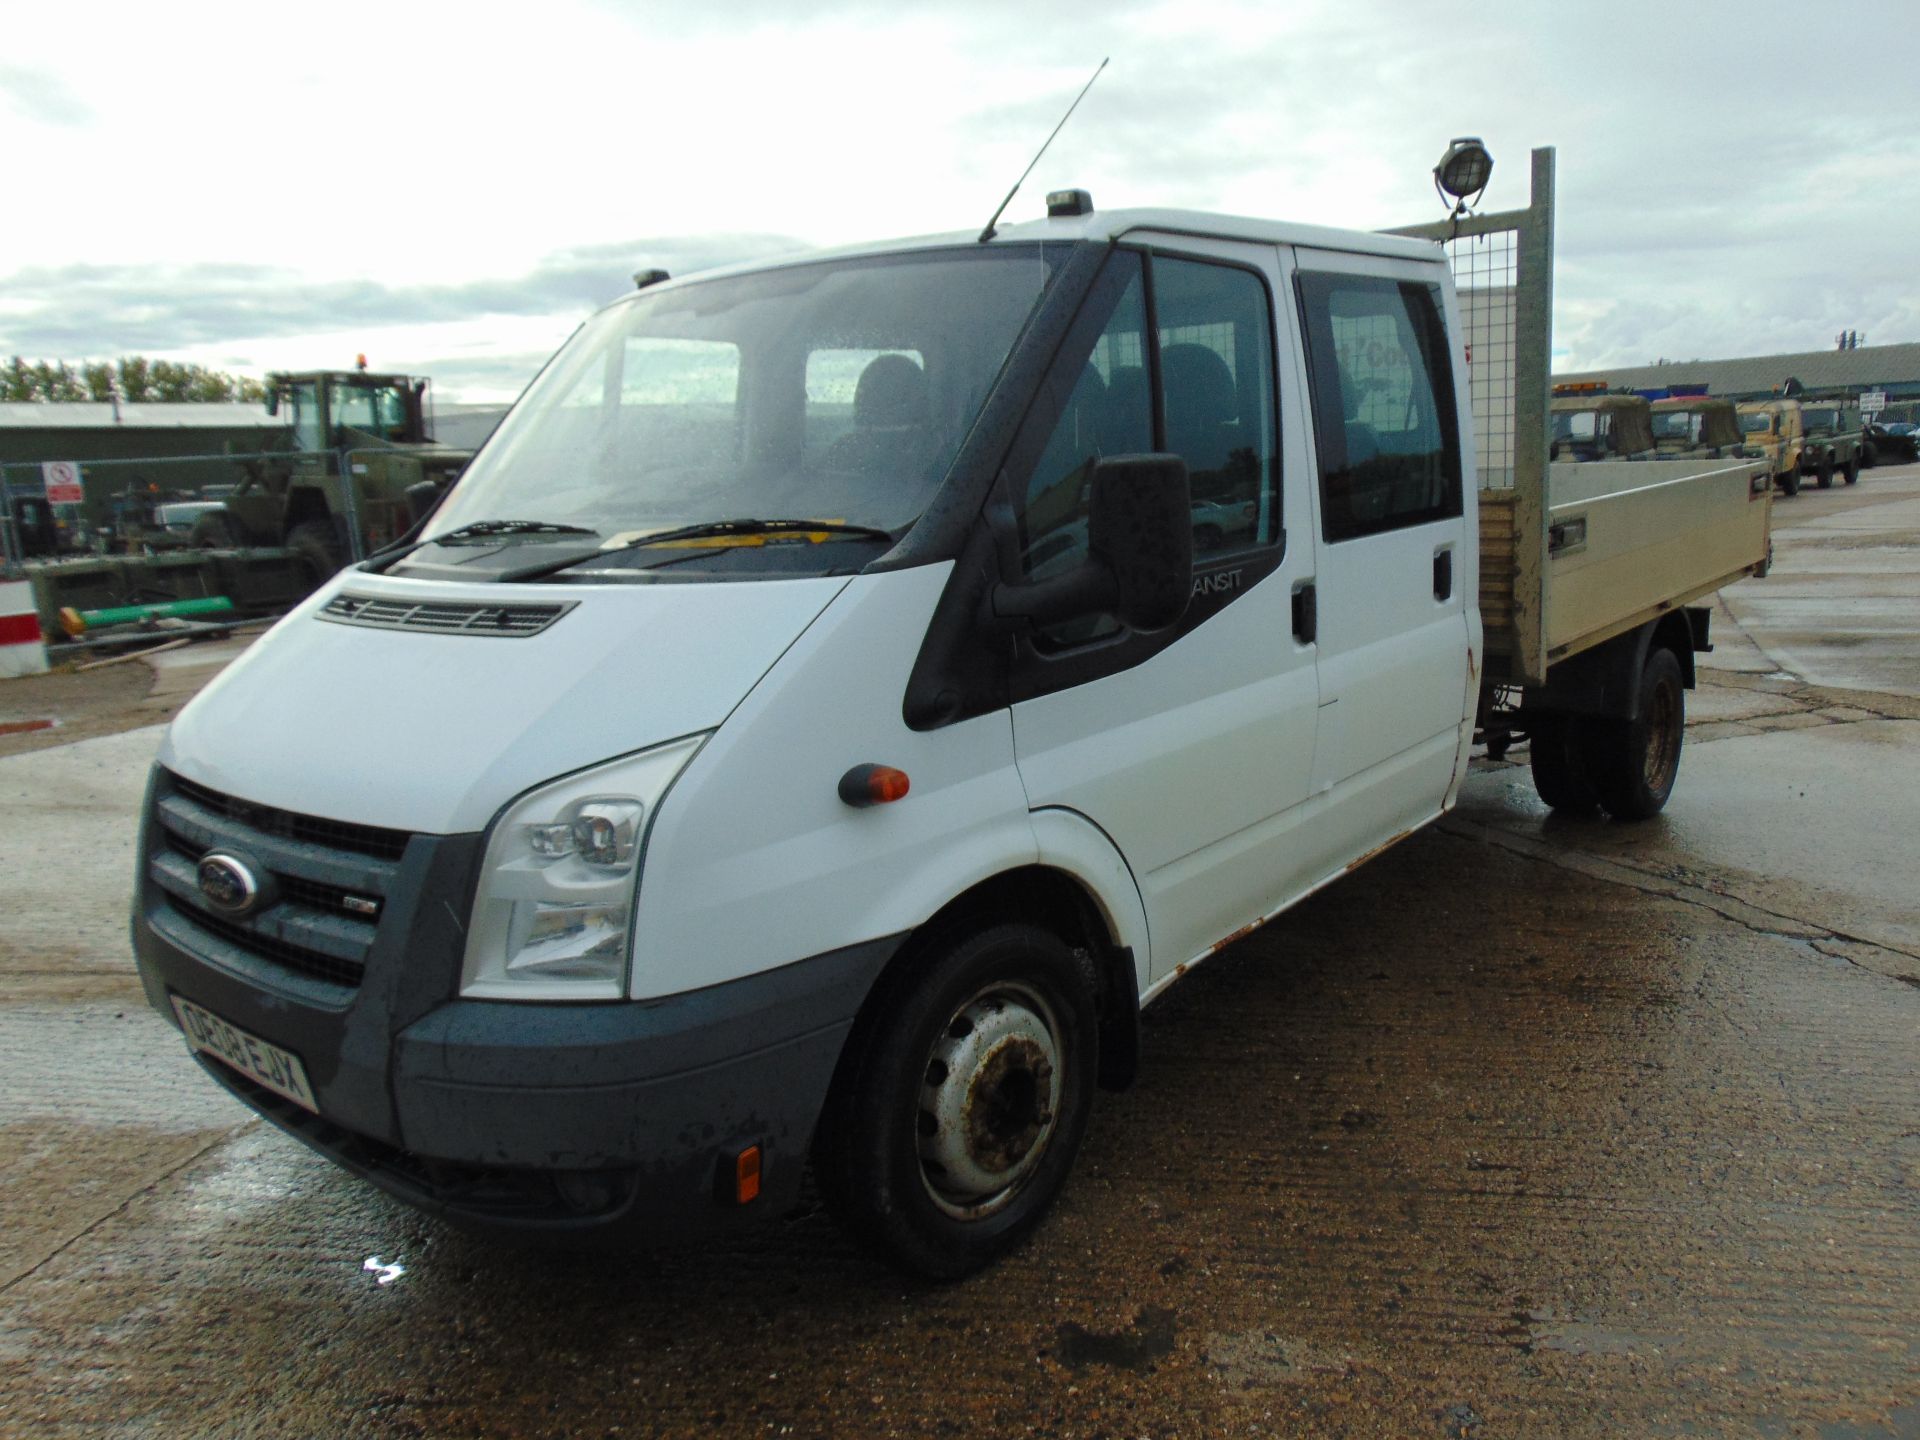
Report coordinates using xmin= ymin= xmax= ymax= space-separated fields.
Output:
xmin=998 ymin=238 xmax=1319 ymax=979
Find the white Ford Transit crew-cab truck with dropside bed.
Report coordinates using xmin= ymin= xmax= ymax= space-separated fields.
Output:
xmin=132 ymin=152 xmax=1770 ymax=1277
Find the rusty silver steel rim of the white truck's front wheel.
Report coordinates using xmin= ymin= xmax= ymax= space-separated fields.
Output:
xmin=914 ymin=981 xmax=1066 ymax=1219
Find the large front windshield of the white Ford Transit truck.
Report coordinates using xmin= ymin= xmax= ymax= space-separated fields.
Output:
xmin=434 ymin=246 xmax=1068 ymax=549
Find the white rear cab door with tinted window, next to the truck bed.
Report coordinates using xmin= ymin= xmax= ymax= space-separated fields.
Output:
xmin=1288 ymin=248 xmax=1480 ymax=856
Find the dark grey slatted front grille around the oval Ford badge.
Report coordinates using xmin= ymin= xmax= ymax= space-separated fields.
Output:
xmin=148 ymin=776 xmax=409 ymax=987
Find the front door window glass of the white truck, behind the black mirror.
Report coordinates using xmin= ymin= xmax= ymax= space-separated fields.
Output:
xmin=1016 ymin=255 xmax=1281 ymax=602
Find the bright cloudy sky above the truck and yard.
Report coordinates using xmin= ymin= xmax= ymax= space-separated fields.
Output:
xmin=0 ymin=0 xmax=1920 ymax=401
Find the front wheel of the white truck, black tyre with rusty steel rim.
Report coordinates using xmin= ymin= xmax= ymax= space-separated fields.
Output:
xmin=814 ymin=924 xmax=1098 ymax=1281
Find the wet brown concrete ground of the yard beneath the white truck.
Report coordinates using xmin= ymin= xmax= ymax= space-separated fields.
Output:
xmin=0 ymin=468 xmax=1920 ymax=1440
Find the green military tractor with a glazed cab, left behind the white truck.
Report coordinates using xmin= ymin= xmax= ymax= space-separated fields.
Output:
xmin=192 ymin=369 xmax=472 ymax=580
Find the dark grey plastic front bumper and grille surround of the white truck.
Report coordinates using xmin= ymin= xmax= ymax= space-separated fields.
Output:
xmin=132 ymin=772 xmax=899 ymax=1244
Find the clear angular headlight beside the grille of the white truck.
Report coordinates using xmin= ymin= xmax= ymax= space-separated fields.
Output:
xmin=461 ymin=735 xmax=705 ymax=1000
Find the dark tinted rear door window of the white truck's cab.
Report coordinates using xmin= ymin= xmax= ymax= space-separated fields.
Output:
xmin=1298 ymin=271 xmax=1461 ymax=541
